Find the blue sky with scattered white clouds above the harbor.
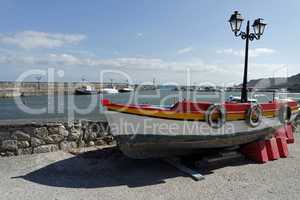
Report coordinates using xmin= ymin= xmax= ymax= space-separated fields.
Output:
xmin=0 ymin=0 xmax=300 ymax=85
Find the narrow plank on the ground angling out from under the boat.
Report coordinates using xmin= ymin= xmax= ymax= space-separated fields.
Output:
xmin=164 ymin=158 xmax=205 ymax=181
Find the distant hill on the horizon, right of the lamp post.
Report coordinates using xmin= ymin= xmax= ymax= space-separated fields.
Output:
xmin=240 ymin=73 xmax=300 ymax=92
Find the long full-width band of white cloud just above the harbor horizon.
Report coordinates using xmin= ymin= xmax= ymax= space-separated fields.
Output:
xmin=0 ymin=52 xmax=299 ymax=85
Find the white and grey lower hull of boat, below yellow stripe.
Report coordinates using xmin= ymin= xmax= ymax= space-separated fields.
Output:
xmin=106 ymin=111 xmax=296 ymax=159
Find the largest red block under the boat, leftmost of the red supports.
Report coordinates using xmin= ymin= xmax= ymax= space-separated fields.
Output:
xmin=240 ymin=141 xmax=269 ymax=163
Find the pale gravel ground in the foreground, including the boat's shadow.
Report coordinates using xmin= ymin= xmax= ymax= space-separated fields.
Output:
xmin=0 ymin=132 xmax=300 ymax=200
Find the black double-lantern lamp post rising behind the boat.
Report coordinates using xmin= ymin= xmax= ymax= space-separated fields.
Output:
xmin=229 ymin=11 xmax=267 ymax=103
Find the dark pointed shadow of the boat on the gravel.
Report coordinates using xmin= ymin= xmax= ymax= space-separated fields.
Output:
xmin=13 ymin=148 xmax=253 ymax=188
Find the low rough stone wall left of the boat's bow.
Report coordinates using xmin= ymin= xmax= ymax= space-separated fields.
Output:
xmin=0 ymin=120 xmax=114 ymax=156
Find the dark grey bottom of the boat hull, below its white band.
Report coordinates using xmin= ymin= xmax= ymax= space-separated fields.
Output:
xmin=116 ymin=127 xmax=279 ymax=159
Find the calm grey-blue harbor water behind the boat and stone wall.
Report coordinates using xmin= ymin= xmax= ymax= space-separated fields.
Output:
xmin=0 ymin=90 xmax=300 ymax=122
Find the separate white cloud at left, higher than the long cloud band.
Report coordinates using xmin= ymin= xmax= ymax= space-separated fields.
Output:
xmin=0 ymin=31 xmax=86 ymax=49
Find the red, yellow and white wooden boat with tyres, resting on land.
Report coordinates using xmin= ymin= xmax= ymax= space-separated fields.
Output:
xmin=102 ymin=99 xmax=298 ymax=159
